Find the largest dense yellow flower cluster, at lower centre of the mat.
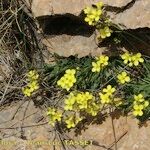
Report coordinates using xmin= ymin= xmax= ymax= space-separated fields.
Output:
xmin=64 ymin=92 xmax=100 ymax=116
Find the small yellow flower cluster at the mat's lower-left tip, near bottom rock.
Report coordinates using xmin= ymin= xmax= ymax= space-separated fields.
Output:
xmin=47 ymin=108 xmax=62 ymax=126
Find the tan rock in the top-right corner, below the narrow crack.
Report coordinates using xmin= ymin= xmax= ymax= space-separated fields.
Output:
xmin=113 ymin=0 xmax=150 ymax=29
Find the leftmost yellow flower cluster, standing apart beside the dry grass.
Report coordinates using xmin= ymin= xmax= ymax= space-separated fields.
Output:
xmin=22 ymin=70 xmax=39 ymax=97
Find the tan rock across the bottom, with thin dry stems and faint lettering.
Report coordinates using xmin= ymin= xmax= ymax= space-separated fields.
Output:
xmin=0 ymin=101 xmax=150 ymax=150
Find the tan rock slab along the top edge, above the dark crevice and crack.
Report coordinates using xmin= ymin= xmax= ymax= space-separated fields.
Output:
xmin=29 ymin=0 xmax=131 ymax=17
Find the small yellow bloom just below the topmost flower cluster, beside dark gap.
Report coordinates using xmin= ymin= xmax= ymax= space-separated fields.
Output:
xmin=99 ymin=27 xmax=112 ymax=39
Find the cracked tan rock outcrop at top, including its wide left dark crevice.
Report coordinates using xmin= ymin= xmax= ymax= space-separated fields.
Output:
xmin=26 ymin=0 xmax=150 ymax=57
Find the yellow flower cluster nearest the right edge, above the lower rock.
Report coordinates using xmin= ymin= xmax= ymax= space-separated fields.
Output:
xmin=133 ymin=94 xmax=149 ymax=116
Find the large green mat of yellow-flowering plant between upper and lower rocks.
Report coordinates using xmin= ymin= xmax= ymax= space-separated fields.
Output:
xmin=41 ymin=52 xmax=150 ymax=128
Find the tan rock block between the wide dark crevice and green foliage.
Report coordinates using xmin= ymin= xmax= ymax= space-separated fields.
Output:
xmin=43 ymin=34 xmax=103 ymax=57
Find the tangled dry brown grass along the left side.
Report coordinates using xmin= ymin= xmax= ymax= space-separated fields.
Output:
xmin=0 ymin=0 xmax=43 ymax=105
